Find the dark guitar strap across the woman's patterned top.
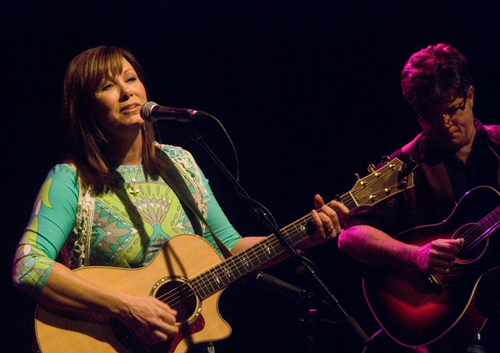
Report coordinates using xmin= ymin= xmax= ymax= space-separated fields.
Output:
xmin=155 ymin=148 xmax=232 ymax=259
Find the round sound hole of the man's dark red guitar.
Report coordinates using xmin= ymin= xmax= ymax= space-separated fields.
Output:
xmin=453 ymin=223 xmax=488 ymax=262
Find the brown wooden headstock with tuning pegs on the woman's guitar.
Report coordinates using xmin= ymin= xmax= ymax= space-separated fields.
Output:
xmin=349 ymin=158 xmax=414 ymax=206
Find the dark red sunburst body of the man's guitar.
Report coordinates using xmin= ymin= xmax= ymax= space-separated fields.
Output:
xmin=363 ymin=187 xmax=500 ymax=353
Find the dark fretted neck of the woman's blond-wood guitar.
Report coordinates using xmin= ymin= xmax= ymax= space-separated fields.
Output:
xmin=191 ymin=193 xmax=357 ymax=299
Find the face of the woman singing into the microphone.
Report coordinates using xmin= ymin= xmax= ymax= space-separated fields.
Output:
xmin=96 ymin=59 xmax=147 ymax=136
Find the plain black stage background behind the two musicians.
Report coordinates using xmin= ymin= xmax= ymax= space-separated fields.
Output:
xmin=0 ymin=0 xmax=500 ymax=353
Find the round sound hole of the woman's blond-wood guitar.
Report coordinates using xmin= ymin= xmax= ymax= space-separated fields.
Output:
xmin=155 ymin=279 xmax=199 ymax=323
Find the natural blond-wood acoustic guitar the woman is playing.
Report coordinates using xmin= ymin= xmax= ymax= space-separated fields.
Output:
xmin=35 ymin=159 xmax=413 ymax=353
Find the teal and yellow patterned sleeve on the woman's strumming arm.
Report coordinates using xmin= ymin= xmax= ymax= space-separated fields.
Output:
xmin=12 ymin=164 xmax=79 ymax=298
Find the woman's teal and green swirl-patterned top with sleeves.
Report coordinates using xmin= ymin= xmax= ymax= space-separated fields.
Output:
xmin=13 ymin=145 xmax=241 ymax=298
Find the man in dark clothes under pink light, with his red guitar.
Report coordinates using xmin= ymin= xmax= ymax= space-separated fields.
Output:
xmin=339 ymin=44 xmax=500 ymax=353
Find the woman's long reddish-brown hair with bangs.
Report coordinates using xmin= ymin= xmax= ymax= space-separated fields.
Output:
xmin=62 ymin=46 xmax=162 ymax=195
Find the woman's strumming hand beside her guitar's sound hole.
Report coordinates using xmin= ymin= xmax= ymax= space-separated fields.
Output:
xmin=118 ymin=296 xmax=179 ymax=345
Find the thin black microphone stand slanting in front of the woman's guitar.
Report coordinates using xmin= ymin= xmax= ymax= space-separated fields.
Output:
xmin=190 ymin=124 xmax=370 ymax=346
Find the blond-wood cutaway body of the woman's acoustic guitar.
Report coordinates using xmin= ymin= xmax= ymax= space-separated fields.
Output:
xmin=35 ymin=234 xmax=231 ymax=353
